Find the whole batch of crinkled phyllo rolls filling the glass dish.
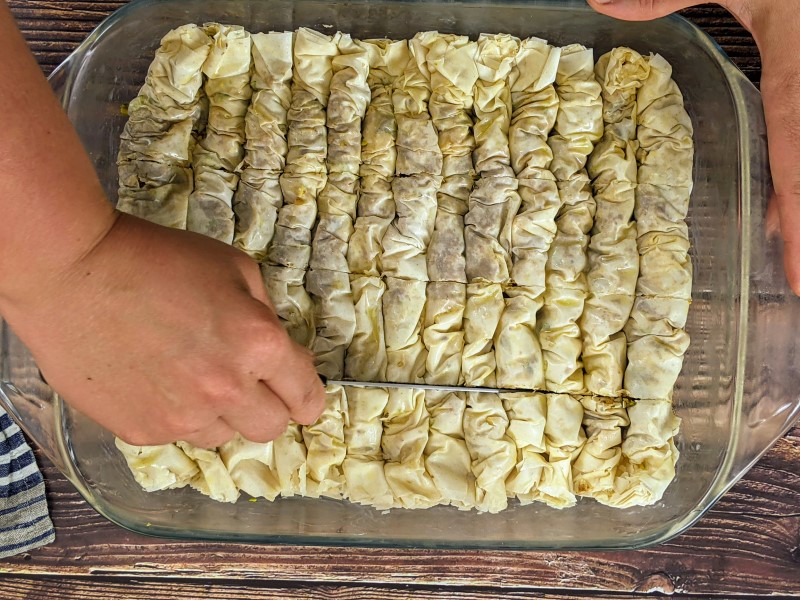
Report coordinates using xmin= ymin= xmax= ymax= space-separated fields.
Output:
xmin=117 ymin=23 xmax=693 ymax=513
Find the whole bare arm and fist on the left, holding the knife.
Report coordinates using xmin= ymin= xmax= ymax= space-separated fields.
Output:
xmin=0 ymin=3 xmax=323 ymax=446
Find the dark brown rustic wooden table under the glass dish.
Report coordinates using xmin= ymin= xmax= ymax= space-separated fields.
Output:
xmin=0 ymin=0 xmax=800 ymax=600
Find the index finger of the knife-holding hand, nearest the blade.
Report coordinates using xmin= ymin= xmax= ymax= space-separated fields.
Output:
xmin=250 ymin=306 xmax=325 ymax=425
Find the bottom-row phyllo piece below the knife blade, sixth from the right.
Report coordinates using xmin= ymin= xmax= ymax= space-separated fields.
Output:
xmin=425 ymin=390 xmax=475 ymax=509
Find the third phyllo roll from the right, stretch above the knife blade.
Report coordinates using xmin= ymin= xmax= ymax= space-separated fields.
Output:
xmin=537 ymin=45 xmax=603 ymax=393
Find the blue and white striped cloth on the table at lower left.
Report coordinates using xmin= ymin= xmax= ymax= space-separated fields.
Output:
xmin=0 ymin=408 xmax=55 ymax=558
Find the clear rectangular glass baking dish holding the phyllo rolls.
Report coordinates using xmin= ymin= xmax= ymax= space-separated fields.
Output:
xmin=0 ymin=0 xmax=800 ymax=549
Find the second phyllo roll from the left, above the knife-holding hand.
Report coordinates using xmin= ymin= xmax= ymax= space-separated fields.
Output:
xmin=186 ymin=23 xmax=253 ymax=244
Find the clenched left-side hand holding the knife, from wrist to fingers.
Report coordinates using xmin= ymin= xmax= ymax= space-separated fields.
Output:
xmin=3 ymin=215 xmax=324 ymax=447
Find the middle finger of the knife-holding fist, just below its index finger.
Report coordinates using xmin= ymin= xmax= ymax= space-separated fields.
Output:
xmin=222 ymin=381 xmax=289 ymax=443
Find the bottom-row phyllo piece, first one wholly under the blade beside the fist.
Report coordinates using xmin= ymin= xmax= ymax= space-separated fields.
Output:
xmin=342 ymin=387 xmax=395 ymax=510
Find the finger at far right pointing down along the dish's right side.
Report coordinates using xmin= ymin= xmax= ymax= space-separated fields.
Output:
xmin=761 ymin=67 xmax=800 ymax=295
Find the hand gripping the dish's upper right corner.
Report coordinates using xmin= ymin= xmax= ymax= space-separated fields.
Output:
xmin=588 ymin=0 xmax=800 ymax=295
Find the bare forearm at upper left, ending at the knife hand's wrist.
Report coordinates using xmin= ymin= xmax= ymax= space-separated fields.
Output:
xmin=0 ymin=1 xmax=116 ymax=312
